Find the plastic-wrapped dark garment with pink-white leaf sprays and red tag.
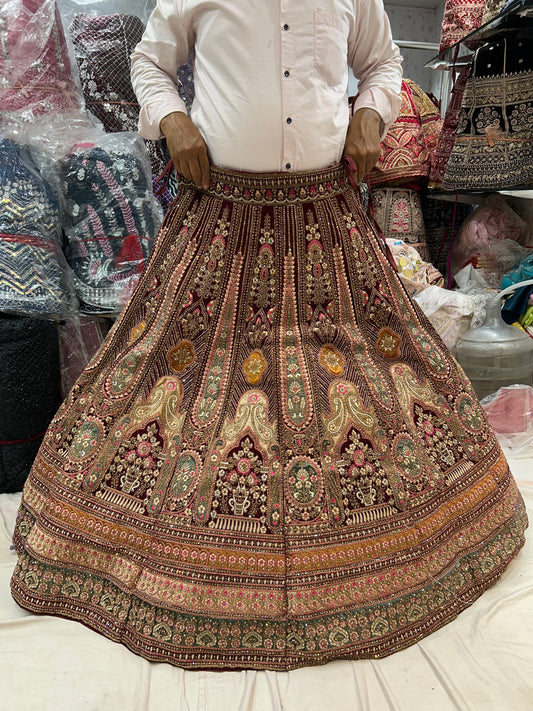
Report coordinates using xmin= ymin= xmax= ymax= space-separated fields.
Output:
xmin=15 ymin=114 xmax=163 ymax=315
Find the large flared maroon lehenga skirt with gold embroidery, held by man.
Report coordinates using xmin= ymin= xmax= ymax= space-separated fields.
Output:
xmin=12 ymin=167 xmax=527 ymax=670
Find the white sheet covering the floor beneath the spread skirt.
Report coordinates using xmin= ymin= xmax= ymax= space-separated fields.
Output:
xmin=0 ymin=456 xmax=533 ymax=711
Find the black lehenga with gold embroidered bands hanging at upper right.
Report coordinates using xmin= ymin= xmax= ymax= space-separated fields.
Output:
xmin=442 ymin=28 xmax=533 ymax=190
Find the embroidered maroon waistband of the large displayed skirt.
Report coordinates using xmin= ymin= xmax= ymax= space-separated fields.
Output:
xmin=180 ymin=164 xmax=350 ymax=205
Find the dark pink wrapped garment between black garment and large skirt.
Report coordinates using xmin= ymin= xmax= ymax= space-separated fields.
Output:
xmin=59 ymin=314 xmax=113 ymax=400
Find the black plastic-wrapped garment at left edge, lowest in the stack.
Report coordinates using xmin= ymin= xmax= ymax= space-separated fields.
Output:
xmin=0 ymin=314 xmax=60 ymax=493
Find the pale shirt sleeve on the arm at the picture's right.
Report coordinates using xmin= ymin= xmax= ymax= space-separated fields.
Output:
xmin=348 ymin=0 xmax=402 ymax=138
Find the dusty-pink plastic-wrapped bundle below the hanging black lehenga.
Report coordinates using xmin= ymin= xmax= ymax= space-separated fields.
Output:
xmin=452 ymin=194 xmax=527 ymax=287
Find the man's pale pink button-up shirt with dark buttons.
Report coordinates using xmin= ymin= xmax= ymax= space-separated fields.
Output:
xmin=132 ymin=0 xmax=402 ymax=172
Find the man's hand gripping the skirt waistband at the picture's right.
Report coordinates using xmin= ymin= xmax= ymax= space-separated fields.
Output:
xmin=344 ymin=108 xmax=382 ymax=183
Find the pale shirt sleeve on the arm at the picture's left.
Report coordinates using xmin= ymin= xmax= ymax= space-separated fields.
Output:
xmin=131 ymin=0 xmax=194 ymax=140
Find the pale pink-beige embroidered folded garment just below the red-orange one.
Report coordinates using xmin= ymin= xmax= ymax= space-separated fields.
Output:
xmin=372 ymin=188 xmax=426 ymax=243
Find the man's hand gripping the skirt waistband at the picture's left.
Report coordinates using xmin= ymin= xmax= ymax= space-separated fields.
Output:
xmin=160 ymin=111 xmax=209 ymax=188
